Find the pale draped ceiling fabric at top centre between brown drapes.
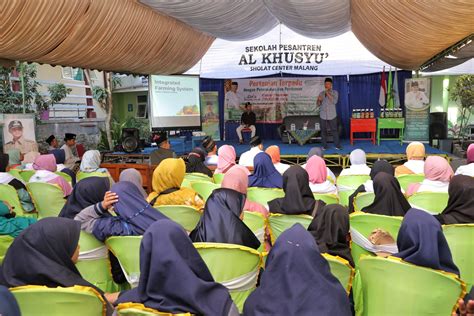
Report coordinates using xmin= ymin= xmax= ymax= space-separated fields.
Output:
xmin=140 ymin=0 xmax=351 ymax=40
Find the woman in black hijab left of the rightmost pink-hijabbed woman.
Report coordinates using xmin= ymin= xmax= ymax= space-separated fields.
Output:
xmin=361 ymin=172 xmax=411 ymax=216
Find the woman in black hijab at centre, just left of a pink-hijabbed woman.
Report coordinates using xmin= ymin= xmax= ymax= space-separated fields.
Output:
xmin=268 ymin=165 xmax=324 ymax=216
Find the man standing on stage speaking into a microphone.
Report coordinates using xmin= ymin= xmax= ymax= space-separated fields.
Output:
xmin=316 ymin=78 xmax=342 ymax=150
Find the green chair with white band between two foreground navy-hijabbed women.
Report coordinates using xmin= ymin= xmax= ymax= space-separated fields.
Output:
xmin=194 ymin=243 xmax=262 ymax=313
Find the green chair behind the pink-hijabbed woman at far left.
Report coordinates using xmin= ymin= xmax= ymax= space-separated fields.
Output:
xmin=26 ymin=182 xmax=66 ymax=219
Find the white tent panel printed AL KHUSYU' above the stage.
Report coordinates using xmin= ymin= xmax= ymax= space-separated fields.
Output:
xmin=186 ymin=25 xmax=394 ymax=78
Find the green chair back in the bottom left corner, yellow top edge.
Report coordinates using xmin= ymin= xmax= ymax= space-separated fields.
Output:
xmin=10 ymin=285 xmax=105 ymax=316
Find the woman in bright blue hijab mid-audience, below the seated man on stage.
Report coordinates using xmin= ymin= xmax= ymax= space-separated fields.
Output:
xmin=249 ymin=152 xmax=283 ymax=189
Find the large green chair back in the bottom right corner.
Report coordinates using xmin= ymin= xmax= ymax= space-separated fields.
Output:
xmin=354 ymin=257 xmax=465 ymax=316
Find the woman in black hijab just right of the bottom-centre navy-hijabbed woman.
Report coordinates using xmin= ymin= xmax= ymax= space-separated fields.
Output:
xmin=308 ymin=204 xmax=354 ymax=266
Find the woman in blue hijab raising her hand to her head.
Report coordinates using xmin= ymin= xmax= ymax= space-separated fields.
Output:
xmin=74 ymin=181 xmax=167 ymax=241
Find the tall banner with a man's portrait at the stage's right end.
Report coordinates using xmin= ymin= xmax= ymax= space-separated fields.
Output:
xmin=404 ymin=78 xmax=431 ymax=141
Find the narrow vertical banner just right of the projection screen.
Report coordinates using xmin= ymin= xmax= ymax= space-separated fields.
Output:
xmin=201 ymin=91 xmax=221 ymax=140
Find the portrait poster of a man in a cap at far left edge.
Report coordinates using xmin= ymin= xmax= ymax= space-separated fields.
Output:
xmin=3 ymin=114 xmax=38 ymax=154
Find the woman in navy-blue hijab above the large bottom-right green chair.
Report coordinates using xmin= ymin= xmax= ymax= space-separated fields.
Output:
xmin=394 ymin=208 xmax=459 ymax=276
